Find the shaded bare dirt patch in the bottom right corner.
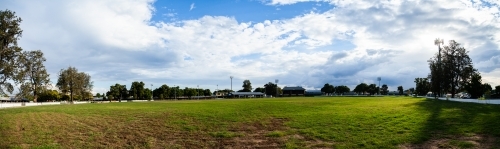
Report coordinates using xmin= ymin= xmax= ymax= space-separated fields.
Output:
xmin=399 ymin=134 xmax=496 ymax=149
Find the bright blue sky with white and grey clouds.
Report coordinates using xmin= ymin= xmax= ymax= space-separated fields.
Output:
xmin=0 ymin=0 xmax=500 ymax=93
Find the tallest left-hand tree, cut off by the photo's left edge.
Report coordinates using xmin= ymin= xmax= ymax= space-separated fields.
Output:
xmin=0 ymin=10 xmax=23 ymax=94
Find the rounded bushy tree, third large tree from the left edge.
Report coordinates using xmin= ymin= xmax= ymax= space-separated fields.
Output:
xmin=56 ymin=67 xmax=93 ymax=102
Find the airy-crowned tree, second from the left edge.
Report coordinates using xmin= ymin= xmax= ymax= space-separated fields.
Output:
xmin=17 ymin=50 xmax=50 ymax=102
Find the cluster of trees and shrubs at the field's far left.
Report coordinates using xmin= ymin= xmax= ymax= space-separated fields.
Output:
xmin=0 ymin=10 xmax=92 ymax=102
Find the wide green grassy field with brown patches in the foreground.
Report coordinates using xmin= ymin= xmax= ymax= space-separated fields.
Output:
xmin=0 ymin=97 xmax=500 ymax=148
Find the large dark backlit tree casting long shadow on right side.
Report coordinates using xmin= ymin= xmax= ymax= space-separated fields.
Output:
xmin=429 ymin=40 xmax=477 ymax=98
